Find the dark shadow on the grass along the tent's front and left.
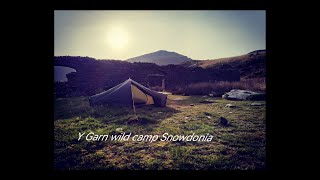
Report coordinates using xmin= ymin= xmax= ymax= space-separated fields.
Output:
xmin=54 ymin=98 xmax=180 ymax=125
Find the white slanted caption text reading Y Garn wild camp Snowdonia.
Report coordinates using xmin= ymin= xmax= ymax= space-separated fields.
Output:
xmin=78 ymin=132 xmax=213 ymax=143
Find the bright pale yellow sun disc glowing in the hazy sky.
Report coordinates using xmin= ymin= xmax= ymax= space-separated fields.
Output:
xmin=107 ymin=28 xmax=128 ymax=49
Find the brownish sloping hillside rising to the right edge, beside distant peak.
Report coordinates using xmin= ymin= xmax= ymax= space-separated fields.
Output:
xmin=181 ymin=50 xmax=266 ymax=79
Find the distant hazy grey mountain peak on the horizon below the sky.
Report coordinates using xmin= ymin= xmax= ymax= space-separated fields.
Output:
xmin=127 ymin=50 xmax=192 ymax=66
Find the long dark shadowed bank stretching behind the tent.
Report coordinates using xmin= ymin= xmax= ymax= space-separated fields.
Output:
xmin=54 ymin=56 xmax=240 ymax=97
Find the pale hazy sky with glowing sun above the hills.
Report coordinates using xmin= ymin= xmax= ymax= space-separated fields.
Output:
xmin=54 ymin=10 xmax=266 ymax=60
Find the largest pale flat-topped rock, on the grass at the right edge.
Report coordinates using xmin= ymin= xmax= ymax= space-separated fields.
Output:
xmin=222 ymin=89 xmax=266 ymax=101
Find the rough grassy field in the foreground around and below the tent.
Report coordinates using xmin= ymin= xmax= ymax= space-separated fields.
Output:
xmin=54 ymin=95 xmax=266 ymax=170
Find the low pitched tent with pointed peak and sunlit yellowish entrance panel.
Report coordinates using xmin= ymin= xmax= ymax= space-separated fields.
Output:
xmin=89 ymin=78 xmax=167 ymax=106
